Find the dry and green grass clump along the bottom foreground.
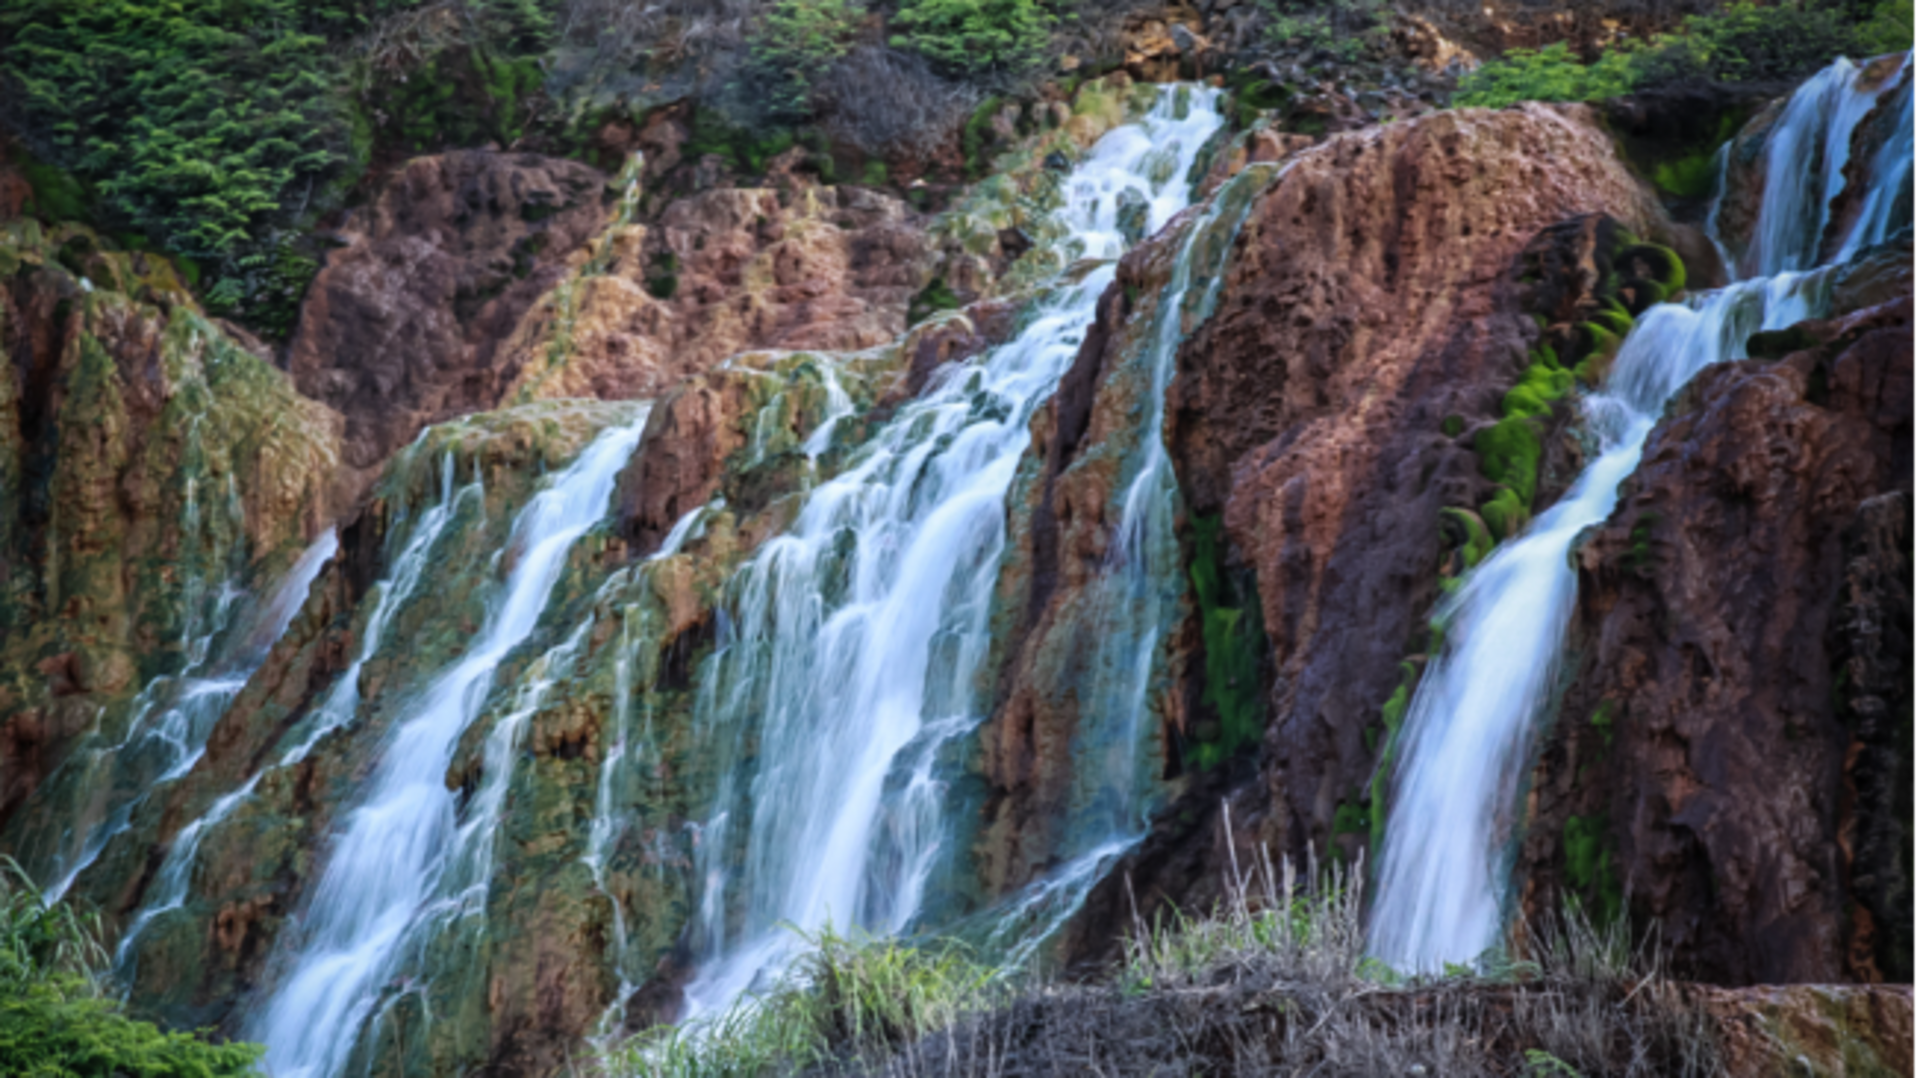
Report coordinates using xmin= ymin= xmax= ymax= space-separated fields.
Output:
xmin=611 ymin=803 xmax=1720 ymax=1078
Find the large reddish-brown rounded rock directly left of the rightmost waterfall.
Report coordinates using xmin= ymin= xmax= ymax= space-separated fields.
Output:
xmin=1165 ymin=106 xmax=1661 ymax=876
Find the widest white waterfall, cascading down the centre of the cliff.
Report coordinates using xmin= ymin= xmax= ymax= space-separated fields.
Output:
xmin=685 ymin=86 xmax=1221 ymax=1018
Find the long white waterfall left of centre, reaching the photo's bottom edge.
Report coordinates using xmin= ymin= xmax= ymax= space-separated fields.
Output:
xmin=248 ymin=413 xmax=645 ymax=1078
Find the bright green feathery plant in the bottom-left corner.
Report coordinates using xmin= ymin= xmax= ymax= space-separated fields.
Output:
xmin=0 ymin=859 xmax=263 ymax=1078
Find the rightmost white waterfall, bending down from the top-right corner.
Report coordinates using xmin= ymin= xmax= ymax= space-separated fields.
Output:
xmin=1371 ymin=54 xmax=1916 ymax=970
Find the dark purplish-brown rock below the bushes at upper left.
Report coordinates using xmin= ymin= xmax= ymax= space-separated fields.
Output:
xmin=286 ymin=150 xmax=611 ymax=469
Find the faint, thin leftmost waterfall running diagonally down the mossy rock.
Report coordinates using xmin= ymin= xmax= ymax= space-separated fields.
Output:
xmin=44 ymin=522 xmax=340 ymax=903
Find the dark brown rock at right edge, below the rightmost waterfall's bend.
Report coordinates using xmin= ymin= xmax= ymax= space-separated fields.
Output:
xmin=1517 ymin=251 xmax=1920 ymax=984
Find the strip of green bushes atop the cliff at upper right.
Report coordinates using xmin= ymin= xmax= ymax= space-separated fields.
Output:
xmin=1453 ymin=0 xmax=1920 ymax=108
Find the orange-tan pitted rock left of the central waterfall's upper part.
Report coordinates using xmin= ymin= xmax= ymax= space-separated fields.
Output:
xmin=501 ymin=183 xmax=933 ymax=400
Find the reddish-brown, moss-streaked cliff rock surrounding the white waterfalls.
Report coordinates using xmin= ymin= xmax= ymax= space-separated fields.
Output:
xmin=0 ymin=39 xmax=1920 ymax=1072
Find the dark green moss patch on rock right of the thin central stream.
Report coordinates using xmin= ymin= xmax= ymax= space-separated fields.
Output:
xmin=1187 ymin=513 xmax=1267 ymax=771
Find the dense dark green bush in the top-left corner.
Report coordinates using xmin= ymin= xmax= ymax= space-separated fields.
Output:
xmin=0 ymin=0 xmax=362 ymax=259
